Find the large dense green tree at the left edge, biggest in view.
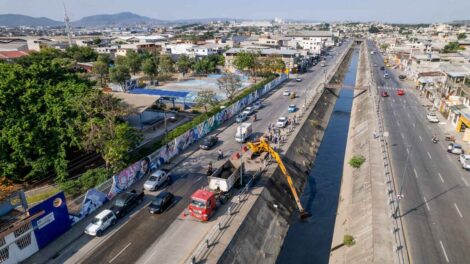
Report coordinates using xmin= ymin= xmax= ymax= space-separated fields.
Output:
xmin=0 ymin=62 xmax=93 ymax=181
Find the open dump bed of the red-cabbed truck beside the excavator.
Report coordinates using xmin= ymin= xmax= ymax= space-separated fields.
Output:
xmin=207 ymin=160 xmax=241 ymax=193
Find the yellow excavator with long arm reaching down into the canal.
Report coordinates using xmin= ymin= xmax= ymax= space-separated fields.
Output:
xmin=247 ymin=137 xmax=310 ymax=219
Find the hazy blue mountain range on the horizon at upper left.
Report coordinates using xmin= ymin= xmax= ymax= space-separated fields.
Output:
xmin=0 ymin=12 xmax=234 ymax=27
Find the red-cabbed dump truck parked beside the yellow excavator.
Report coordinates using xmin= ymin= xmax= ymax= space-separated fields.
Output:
xmin=188 ymin=160 xmax=242 ymax=221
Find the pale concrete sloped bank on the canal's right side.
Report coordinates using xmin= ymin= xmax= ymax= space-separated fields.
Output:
xmin=329 ymin=42 xmax=396 ymax=264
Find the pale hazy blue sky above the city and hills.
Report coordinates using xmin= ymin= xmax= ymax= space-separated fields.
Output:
xmin=0 ymin=0 xmax=470 ymax=23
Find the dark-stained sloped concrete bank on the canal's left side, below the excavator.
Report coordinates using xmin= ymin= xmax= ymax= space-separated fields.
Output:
xmin=214 ymin=46 xmax=352 ymax=263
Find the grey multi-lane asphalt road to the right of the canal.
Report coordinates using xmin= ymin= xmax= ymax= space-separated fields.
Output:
xmin=368 ymin=39 xmax=470 ymax=263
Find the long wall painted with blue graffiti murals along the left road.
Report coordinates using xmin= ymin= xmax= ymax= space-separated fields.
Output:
xmin=71 ymin=75 xmax=287 ymax=223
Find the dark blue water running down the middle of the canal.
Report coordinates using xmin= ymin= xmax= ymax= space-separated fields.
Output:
xmin=277 ymin=48 xmax=359 ymax=264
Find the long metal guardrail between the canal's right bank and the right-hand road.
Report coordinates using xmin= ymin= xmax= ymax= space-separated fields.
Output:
xmin=364 ymin=43 xmax=410 ymax=264
